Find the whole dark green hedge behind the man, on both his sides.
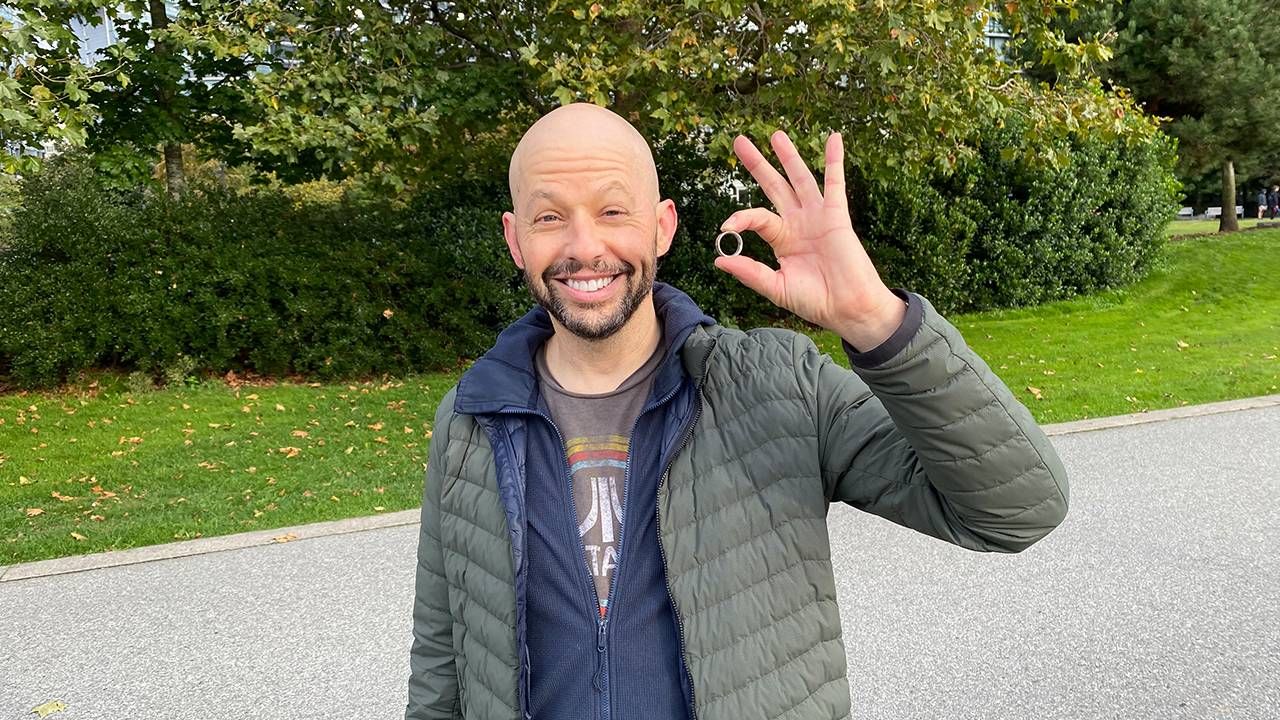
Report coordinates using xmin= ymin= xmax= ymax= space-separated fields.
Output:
xmin=0 ymin=128 xmax=1176 ymax=386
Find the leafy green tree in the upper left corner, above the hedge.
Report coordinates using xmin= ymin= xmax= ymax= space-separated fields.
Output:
xmin=0 ymin=0 xmax=274 ymax=195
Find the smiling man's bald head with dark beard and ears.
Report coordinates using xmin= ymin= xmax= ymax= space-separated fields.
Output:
xmin=502 ymin=104 xmax=676 ymax=340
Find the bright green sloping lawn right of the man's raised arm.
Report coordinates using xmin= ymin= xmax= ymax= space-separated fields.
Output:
xmin=815 ymin=231 xmax=1280 ymax=423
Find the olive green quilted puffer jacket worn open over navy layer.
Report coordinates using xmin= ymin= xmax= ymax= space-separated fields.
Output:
xmin=406 ymin=288 xmax=1068 ymax=720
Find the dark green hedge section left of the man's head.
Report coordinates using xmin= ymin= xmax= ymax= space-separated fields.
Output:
xmin=0 ymin=161 xmax=526 ymax=386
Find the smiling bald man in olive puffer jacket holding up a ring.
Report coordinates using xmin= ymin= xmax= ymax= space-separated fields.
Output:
xmin=406 ymin=105 xmax=1068 ymax=720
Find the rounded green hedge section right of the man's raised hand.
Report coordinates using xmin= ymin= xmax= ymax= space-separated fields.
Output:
xmin=854 ymin=121 xmax=1179 ymax=313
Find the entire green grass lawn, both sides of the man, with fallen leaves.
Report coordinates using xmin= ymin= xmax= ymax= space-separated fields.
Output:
xmin=0 ymin=231 xmax=1280 ymax=564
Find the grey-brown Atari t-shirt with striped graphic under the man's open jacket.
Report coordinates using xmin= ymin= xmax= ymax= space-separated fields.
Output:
xmin=536 ymin=345 xmax=663 ymax=618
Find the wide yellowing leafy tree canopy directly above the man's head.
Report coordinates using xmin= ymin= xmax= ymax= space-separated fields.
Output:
xmin=237 ymin=0 xmax=1149 ymax=186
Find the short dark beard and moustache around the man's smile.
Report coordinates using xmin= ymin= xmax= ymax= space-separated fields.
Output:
xmin=524 ymin=251 xmax=657 ymax=341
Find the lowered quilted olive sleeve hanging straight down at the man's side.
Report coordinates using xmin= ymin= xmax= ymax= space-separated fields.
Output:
xmin=404 ymin=392 xmax=462 ymax=720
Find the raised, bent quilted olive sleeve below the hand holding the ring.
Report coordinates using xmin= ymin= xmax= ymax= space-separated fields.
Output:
xmin=796 ymin=292 xmax=1068 ymax=552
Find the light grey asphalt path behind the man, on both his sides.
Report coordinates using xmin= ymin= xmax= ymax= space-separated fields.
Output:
xmin=0 ymin=406 xmax=1280 ymax=720
